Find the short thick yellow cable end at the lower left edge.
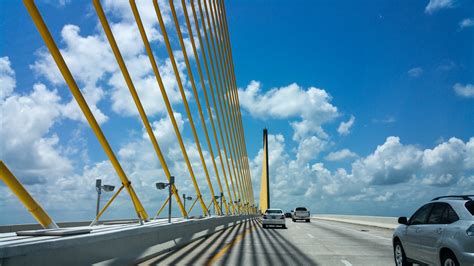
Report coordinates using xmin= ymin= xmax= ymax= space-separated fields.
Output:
xmin=0 ymin=161 xmax=59 ymax=229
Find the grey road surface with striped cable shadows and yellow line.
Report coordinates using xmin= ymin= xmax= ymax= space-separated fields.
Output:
xmin=138 ymin=219 xmax=394 ymax=266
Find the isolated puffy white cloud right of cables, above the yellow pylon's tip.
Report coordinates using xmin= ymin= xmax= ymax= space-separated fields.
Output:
xmin=239 ymin=81 xmax=339 ymax=140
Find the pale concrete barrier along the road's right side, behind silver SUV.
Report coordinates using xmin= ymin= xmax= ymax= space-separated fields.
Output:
xmin=312 ymin=214 xmax=398 ymax=229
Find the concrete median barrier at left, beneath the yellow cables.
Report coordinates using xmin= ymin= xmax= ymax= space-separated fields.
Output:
xmin=0 ymin=215 xmax=254 ymax=266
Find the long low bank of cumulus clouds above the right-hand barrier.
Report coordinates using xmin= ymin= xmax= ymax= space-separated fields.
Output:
xmin=252 ymin=135 xmax=474 ymax=215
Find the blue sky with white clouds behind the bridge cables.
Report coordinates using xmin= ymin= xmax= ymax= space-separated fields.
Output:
xmin=0 ymin=0 xmax=474 ymax=224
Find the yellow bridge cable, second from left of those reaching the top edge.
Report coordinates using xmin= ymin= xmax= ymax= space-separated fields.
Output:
xmin=94 ymin=0 xmax=187 ymax=217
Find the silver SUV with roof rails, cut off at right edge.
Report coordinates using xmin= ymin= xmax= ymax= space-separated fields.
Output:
xmin=393 ymin=195 xmax=474 ymax=266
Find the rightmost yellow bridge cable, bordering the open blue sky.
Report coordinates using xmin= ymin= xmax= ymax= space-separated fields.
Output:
xmin=220 ymin=1 xmax=255 ymax=206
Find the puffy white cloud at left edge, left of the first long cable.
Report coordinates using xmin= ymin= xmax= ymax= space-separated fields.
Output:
xmin=0 ymin=83 xmax=72 ymax=184
